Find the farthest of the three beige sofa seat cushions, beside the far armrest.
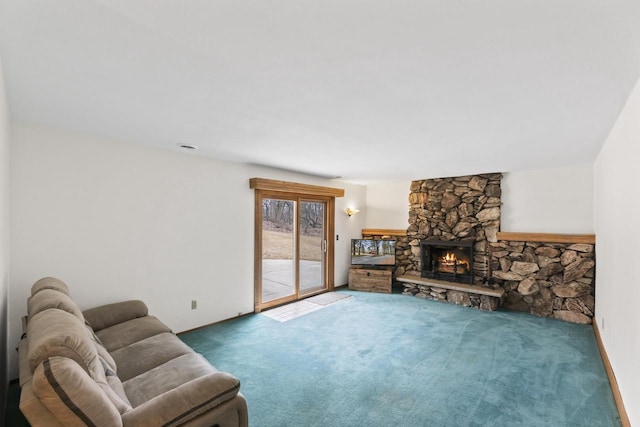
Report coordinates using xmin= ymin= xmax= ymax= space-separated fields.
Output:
xmin=96 ymin=316 xmax=171 ymax=352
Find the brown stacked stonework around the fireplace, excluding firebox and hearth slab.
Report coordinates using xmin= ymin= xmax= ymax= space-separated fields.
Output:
xmin=370 ymin=173 xmax=595 ymax=324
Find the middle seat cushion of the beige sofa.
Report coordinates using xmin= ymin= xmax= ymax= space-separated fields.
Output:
xmin=111 ymin=332 xmax=193 ymax=381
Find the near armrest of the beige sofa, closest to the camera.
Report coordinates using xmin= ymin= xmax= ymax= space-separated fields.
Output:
xmin=122 ymin=372 xmax=240 ymax=427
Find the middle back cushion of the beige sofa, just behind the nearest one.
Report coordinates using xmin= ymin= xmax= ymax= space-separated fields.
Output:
xmin=27 ymin=308 xmax=102 ymax=378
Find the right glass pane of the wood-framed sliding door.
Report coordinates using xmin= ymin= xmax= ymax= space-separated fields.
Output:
xmin=300 ymin=201 xmax=327 ymax=294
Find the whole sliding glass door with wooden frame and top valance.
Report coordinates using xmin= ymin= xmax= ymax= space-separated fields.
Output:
xmin=249 ymin=178 xmax=344 ymax=312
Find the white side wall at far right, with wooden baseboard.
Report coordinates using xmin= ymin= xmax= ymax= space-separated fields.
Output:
xmin=594 ymin=76 xmax=640 ymax=426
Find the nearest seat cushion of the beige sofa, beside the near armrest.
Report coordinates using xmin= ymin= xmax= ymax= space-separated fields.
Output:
xmin=122 ymin=353 xmax=218 ymax=408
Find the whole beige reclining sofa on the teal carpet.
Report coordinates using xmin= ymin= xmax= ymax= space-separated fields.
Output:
xmin=18 ymin=277 xmax=248 ymax=427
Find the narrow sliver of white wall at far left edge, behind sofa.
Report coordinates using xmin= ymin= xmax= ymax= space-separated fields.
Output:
xmin=0 ymin=58 xmax=10 ymax=425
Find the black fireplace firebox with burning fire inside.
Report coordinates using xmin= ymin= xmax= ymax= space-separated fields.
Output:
xmin=420 ymin=240 xmax=475 ymax=284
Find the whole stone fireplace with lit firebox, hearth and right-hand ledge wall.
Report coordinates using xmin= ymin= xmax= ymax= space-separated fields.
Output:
xmin=395 ymin=173 xmax=596 ymax=324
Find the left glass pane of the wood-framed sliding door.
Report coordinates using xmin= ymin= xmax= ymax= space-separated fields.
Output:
xmin=262 ymin=198 xmax=296 ymax=303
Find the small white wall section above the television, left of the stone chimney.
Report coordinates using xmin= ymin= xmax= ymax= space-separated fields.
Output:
xmin=365 ymin=181 xmax=411 ymax=230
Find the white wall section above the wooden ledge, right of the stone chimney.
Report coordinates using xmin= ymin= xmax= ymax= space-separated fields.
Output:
xmin=500 ymin=164 xmax=593 ymax=234
